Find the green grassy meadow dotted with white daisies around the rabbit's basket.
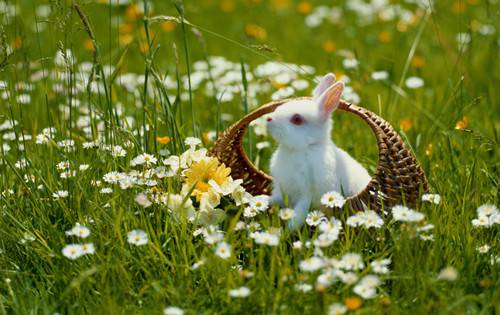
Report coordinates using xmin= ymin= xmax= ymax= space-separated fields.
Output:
xmin=0 ymin=0 xmax=500 ymax=315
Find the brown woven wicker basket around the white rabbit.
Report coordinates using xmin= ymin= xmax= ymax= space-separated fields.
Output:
xmin=211 ymin=97 xmax=428 ymax=210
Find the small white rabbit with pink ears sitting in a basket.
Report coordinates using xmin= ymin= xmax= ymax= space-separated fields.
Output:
xmin=267 ymin=73 xmax=371 ymax=229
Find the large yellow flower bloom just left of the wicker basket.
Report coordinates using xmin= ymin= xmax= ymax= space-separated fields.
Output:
xmin=184 ymin=158 xmax=231 ymax=201
